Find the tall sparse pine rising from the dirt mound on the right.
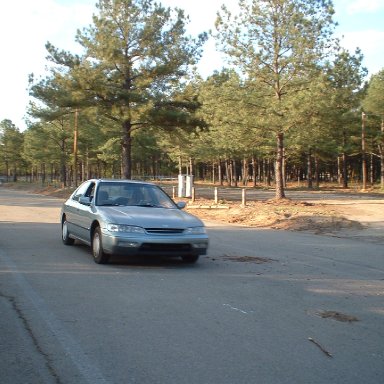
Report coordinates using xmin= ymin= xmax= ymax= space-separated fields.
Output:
xmin=216 ymin=0 xmax=334 ymax=199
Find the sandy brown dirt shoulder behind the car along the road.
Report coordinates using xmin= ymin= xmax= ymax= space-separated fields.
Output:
xmin=3 ymin=183 xmax=384 ymax=244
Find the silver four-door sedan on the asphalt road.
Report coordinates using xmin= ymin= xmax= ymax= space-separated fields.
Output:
xmin=61 ymin=179 xmax=208 ymax=264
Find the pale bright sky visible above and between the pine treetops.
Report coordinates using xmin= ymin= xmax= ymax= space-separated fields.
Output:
xmin=0 ymin=0 xmax=384 ymax=130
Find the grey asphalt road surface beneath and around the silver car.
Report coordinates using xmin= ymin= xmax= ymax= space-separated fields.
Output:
xmin=0 ymin=188 xmax=384 ymax=384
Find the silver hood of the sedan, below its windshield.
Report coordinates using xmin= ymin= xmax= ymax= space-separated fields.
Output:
xmin=98 ymin=206 xmax=204 ymax=228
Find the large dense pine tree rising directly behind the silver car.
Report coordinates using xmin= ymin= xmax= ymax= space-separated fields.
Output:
xmin=48 ymin=0 xmax=207 ymax=178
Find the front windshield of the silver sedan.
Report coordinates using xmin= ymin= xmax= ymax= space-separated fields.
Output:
xmin=95 ymin=182 xmax=176 ymax=208
